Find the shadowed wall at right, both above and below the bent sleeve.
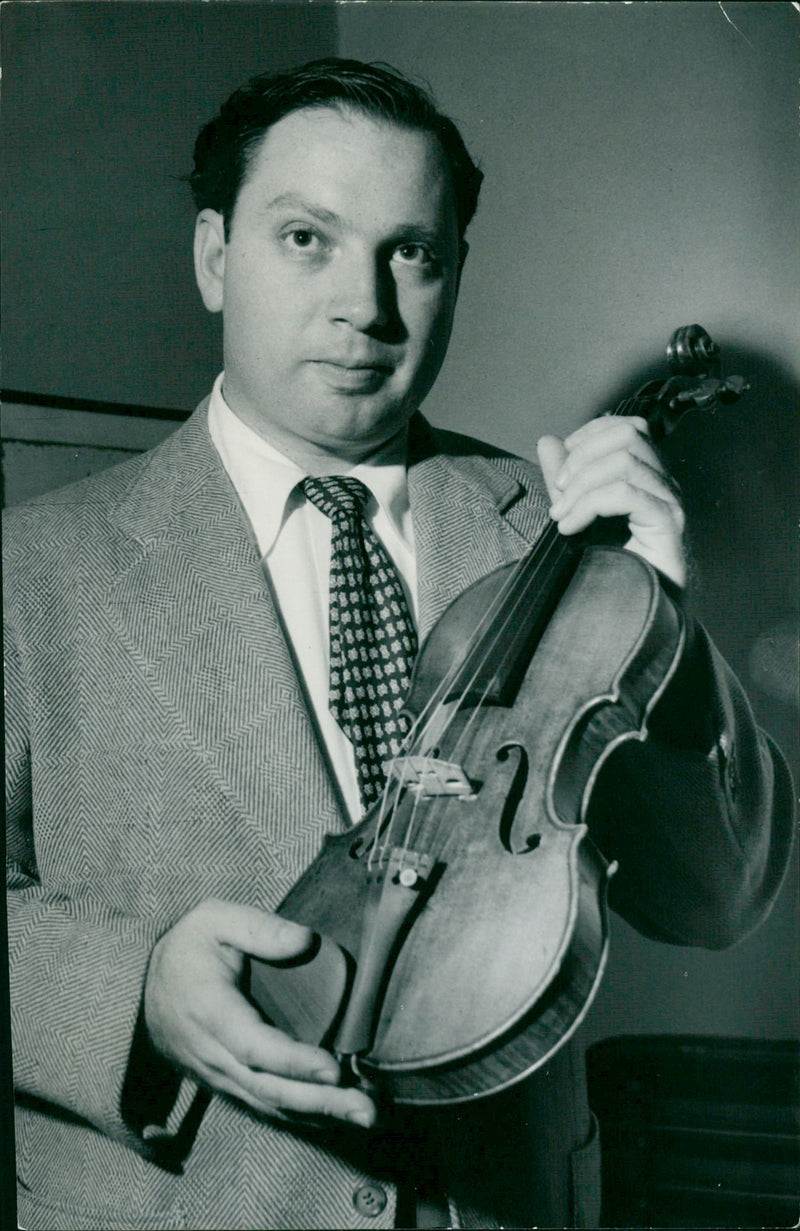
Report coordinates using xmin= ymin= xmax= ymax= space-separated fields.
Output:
xmin=585 ymin=343 xmax=800 ymax=1041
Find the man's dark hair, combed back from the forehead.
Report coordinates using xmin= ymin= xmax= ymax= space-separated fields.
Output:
xmin=188 ymin=57 xmax=484 ymax=239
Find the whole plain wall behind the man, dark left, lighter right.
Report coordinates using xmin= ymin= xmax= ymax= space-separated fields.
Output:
xmin=2 ymin=0 xmax=800 ymax=1038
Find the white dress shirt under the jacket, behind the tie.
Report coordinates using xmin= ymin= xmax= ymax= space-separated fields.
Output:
xmin=208 ymin=373 xmax=417 ymax=821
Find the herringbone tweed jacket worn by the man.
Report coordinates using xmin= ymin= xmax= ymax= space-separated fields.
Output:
xmin=5 ymin=405 xmax=791 ymax=1231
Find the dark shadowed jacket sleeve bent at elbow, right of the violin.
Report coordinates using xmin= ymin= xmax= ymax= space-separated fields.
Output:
xmin=588 ymin=617 xmax=794 ymax=949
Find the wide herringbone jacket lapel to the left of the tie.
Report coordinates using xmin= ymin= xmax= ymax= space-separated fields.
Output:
xmin=103 ymin=405 xmax=345 ymax=891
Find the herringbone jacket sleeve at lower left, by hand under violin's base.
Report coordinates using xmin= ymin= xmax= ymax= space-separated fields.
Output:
xmin=4 ymin=632 xmax=196 ymax=1153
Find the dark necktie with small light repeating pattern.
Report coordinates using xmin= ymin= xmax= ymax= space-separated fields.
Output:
xmin=300 ymin=475 xmax=417 ymax=809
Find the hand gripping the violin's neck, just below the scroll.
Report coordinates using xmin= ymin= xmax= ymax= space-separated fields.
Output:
xmin=537 ymin=416 xmax=687 ymax=588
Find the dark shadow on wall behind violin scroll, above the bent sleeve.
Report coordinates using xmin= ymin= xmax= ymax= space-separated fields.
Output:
xmin=595 ymin=343 xmax=800 ymax=780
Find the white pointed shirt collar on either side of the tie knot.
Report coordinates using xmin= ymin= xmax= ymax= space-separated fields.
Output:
xmin=208 ymin=372 xmax=414 ymax=555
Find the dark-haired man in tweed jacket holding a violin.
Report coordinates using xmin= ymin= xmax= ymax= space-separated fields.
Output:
xmin=6 ymin=62 xmax=791 ymax=1229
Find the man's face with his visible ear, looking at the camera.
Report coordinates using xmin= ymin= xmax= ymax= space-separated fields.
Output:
xmin=197 ymin=100 xmax=459 ymax=463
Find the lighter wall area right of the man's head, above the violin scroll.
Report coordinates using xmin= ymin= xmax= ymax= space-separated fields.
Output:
xmin=338 ymin=0 xmax=800 ymax=443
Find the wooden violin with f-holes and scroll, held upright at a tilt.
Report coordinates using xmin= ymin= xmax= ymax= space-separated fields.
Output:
xmin=246 ymin=325 xmax=747 ymax=1105
